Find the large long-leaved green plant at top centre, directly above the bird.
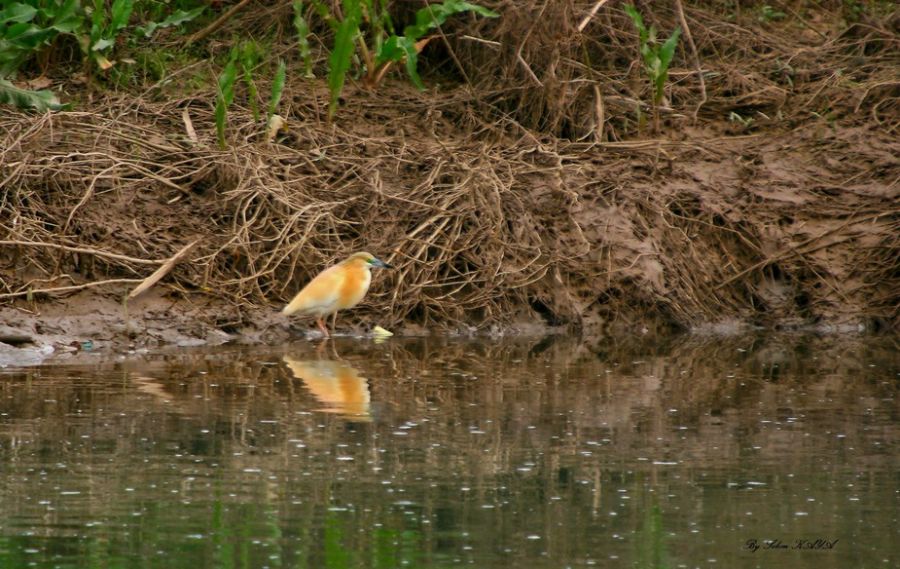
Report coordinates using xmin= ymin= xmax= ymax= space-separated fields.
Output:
xmin=312 ymin=0 xmax=498 ymax=116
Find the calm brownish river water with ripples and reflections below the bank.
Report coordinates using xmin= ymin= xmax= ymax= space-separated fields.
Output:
xmin=0 ymin=335 xmax=900 ymax=569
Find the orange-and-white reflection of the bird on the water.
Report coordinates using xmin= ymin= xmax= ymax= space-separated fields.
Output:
xmin=283 ymin=356 xmax=371 ymax=421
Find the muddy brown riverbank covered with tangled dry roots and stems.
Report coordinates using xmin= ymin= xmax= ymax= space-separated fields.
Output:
xmin=0 ymin=0 xmax=900 ymax=347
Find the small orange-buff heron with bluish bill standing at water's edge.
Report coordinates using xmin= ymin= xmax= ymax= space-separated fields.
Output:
xmin=281 ymin=251 xmax=393 ymax=338
